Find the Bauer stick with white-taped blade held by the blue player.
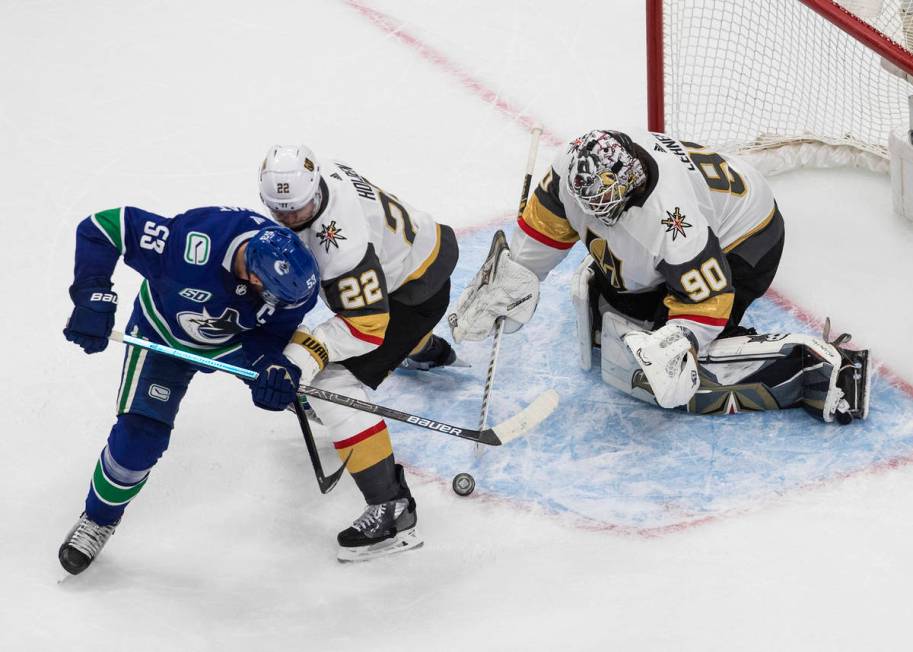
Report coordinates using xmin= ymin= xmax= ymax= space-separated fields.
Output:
xmin=103 ymin=331 xmax=558 ymax=446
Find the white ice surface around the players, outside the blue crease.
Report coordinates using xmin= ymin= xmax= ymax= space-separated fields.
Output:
xmin=0 ymin=0 xmax=913 ymax=651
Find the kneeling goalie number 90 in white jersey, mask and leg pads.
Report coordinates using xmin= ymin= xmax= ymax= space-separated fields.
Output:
xmin=450 ymin=130 xmax=869 ymax=423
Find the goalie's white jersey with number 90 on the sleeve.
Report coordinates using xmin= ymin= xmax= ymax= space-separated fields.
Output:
xmin=511 ymin=130 xmax=775 ymax=348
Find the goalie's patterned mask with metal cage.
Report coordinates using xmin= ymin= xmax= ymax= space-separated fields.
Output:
xmin=567 ymin=130 xmax=647 ymax=226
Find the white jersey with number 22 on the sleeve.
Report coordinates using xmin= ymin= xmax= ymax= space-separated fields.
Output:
xmin=298 ymin=161 xmax=459 ymax=362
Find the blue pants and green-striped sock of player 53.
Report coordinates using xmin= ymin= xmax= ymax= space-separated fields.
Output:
xmin=85 ymin=308 xmax=246 ymax=525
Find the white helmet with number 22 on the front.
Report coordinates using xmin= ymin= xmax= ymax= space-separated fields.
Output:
xmin=260 ymin=145 xmax=322 ymax=213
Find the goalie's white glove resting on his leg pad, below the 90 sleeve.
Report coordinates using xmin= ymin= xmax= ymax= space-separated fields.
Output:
xmin=624 ymin=324 xmax=701 ymax=408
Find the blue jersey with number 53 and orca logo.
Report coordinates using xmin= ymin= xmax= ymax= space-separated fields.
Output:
xmin=73 ymin=206 xmax=317 ymax=360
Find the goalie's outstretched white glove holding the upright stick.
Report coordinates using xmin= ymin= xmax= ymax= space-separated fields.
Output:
xmin=447 ymin=245 xmax=539 ymax=342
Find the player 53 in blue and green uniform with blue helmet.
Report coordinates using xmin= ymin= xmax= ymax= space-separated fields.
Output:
xmin=58 ymin=207 xmax=320 ymax=574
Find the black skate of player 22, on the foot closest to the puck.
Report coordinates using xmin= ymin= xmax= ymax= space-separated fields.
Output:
xmin=336 ymin=464 xmax=424 ymax=562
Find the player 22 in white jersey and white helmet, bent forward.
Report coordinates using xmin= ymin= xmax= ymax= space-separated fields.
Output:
xmin=260 ymin=145 xmax=459 ymax=560
